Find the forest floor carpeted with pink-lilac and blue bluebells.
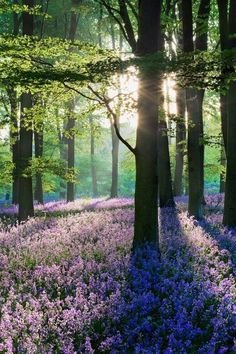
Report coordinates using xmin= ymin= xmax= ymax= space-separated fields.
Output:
xmin=0 ymin=195 xmax=236 ymax=354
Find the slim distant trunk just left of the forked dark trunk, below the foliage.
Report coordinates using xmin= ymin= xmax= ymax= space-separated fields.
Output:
xmin=174 ymin=87 xmax=186 ymax=196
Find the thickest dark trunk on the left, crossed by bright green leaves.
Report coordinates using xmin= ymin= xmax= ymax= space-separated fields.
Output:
xmin=19 ymin=0 xmax=34 ymax=221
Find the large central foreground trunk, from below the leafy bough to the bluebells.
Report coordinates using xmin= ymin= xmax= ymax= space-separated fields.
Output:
xmin=134 ymin=72 xmax=158 ymax=248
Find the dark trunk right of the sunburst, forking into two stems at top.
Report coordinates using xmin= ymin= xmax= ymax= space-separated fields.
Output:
xmin=182 ymin=0 xmax=210 ymax=219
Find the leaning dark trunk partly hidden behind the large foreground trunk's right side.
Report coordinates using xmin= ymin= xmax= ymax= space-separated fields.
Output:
xmin=158 ymin=84 xmax=175 ymax=208
